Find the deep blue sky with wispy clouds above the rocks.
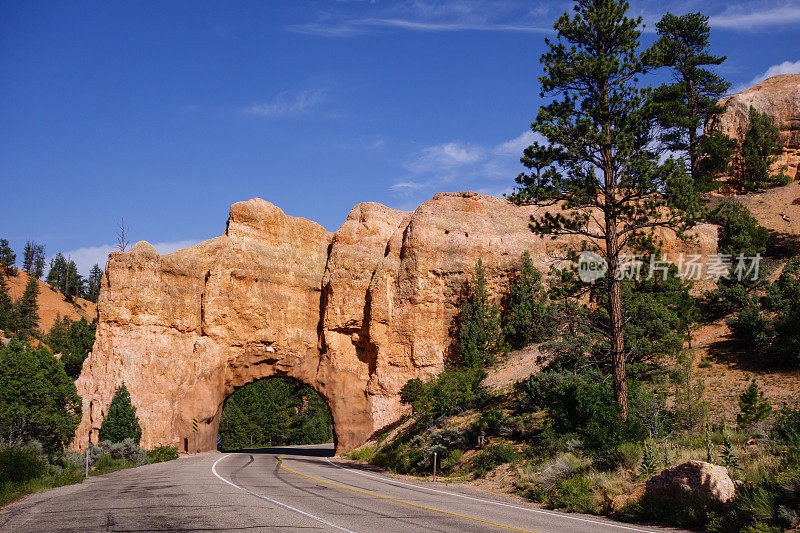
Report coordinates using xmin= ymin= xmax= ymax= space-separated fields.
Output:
xmin=0 ymin=0 xmax=800 ymax=272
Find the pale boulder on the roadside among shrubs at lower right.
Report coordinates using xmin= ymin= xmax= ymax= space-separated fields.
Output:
xmin=644 ymin=461 xmax=736 ymax=504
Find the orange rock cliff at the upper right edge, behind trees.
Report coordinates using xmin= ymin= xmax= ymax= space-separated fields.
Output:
xmin=710 ymin=74 xmax=800 ymax=179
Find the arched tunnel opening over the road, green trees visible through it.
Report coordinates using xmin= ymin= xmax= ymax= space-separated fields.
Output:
xmin=217 ymin=376 xmax=335 ymax=451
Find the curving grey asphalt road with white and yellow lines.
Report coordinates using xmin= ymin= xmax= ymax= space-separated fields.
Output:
xmin=0 ymin=446 xmax=680 ymax=533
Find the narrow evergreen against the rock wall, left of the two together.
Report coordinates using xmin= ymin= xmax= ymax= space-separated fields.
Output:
xmin=456 ymin=259 xmax=500 ymax=368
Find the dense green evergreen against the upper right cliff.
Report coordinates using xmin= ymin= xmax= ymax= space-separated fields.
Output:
xmin=739 ymin=106 xmax=789 ymax=191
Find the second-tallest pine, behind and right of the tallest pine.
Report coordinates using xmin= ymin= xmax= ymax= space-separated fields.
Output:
xmin=645 ymin=13 xmax=735 ymax=192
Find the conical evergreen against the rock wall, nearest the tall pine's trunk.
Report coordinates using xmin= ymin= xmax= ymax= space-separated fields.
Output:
xmin=503 ymin=252 xmax=555 ymax=349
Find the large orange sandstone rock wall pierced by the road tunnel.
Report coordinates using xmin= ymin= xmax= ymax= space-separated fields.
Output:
xmin=75 ymin=193 xmax=716 ymax=451
